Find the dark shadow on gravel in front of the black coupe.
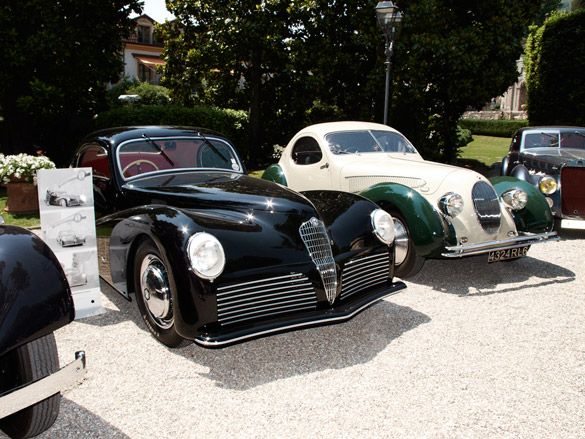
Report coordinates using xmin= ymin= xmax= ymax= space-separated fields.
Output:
xmin=173 ymin=301 xmax=424 ymax=390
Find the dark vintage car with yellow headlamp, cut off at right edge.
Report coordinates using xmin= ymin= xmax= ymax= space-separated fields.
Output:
xmin=501 ymin=127 xmax=585 ymax=229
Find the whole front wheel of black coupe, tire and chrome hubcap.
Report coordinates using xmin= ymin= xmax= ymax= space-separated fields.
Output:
xmin=134 ymin=240 xmax=185 ymax=348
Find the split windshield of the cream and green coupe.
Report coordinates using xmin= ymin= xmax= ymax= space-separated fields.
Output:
xmin=325 ymin=130 xmax=417 ymax=154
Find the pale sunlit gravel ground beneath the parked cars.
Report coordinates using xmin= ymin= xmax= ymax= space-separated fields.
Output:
xmin=5 ymin=231 xmax=585 ymax=438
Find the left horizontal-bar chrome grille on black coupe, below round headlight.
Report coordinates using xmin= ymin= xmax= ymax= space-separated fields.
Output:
xmin=217 ymin=273 xmax=317 ymax=325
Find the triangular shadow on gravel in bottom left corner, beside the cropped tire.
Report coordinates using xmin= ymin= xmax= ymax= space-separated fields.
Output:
xmin=30 ymin=398 xmax=130 ymax=439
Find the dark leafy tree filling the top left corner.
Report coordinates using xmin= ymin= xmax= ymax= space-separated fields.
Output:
xmin=0 ymin=0 xmax=141 ymax=160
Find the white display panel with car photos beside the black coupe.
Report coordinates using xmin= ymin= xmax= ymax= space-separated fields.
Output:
xmin=37 ymin=168 xmax=104 ymax=319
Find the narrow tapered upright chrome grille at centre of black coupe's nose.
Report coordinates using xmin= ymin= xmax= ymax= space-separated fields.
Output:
xmin=299 ymin=217 xmax=337 ymax=303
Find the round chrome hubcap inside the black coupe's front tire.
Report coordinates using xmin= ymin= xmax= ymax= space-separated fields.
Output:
xmin=140 ymin=255 xmax=173 ymax=329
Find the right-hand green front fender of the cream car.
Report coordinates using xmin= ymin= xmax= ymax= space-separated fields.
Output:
xmin=490 ymin=177 xmax=554 ymax=233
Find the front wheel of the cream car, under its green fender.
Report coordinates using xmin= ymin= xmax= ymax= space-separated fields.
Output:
xmin=388 ymin=210 xmax=425 ymax=279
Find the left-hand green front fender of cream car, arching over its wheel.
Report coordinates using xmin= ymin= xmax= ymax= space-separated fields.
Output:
xmin=360 ymin=183 xmax=448 ymax=258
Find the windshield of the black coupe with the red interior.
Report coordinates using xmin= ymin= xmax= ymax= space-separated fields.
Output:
xmin=118 ymin=137 xmax=243 ymax=179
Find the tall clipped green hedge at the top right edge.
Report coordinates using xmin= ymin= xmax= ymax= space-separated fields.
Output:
xmin=525 ymin=9 xmax=585 ymax=125
